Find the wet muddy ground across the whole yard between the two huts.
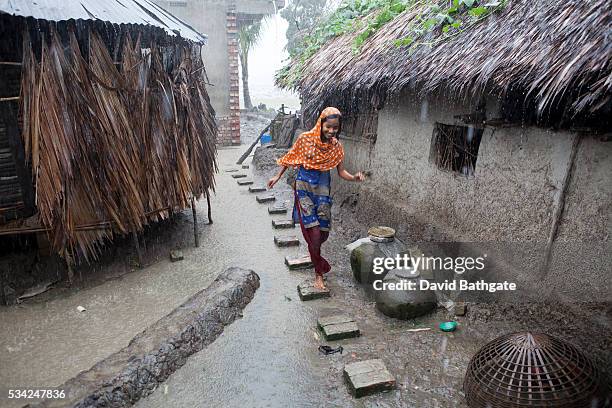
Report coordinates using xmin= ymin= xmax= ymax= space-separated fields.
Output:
xmin=0 ymin=115 xmax=611 ymax=408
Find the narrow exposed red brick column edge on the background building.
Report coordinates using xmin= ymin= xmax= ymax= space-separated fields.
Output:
xmin=217 ymin=2 xmax=240 ymax=146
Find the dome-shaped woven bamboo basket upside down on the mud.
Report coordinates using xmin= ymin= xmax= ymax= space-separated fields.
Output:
xmin=463 ymin=332 xmax=606 ymax=408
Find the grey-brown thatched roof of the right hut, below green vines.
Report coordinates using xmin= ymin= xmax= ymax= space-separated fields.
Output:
xmin=280 ymin=0 xmax=612 ymax=124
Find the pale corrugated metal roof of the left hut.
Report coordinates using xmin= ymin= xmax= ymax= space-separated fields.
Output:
xmin=0 ymin=0 xmax=206 ymax=44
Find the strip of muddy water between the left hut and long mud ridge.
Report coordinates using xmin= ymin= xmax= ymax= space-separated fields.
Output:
xmin=0 ymin=226 xmax=220 ymax=406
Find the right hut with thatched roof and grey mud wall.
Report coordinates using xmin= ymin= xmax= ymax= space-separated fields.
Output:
xmin=277 ymin=0 xmax=612 ymax=302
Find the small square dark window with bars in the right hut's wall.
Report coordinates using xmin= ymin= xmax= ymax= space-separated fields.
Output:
xmin=430 ymin=123 xmax=483 ymax=176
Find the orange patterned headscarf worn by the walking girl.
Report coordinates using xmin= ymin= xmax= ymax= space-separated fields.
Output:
xmin=276 ymin=107 xmax=344 ymax=171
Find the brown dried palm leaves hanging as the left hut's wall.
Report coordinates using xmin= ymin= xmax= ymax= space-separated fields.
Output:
xmin=21 ymin=32 xmax=217 ymax=260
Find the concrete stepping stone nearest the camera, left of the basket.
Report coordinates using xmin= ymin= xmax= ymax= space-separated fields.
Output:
xmin=344 ymin=359 xmax=395 ymax=398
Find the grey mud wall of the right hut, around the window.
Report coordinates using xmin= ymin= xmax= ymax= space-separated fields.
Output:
xmin=334 ymin=95 xmax=612 ymax=301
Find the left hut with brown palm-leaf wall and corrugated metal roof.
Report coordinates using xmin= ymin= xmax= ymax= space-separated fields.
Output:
xmin=0 ymin=0 xmax=217 ymax=278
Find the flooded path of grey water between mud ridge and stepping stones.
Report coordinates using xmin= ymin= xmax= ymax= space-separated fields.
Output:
xmin=137 ymin=150 xmax=347 ymax=407
